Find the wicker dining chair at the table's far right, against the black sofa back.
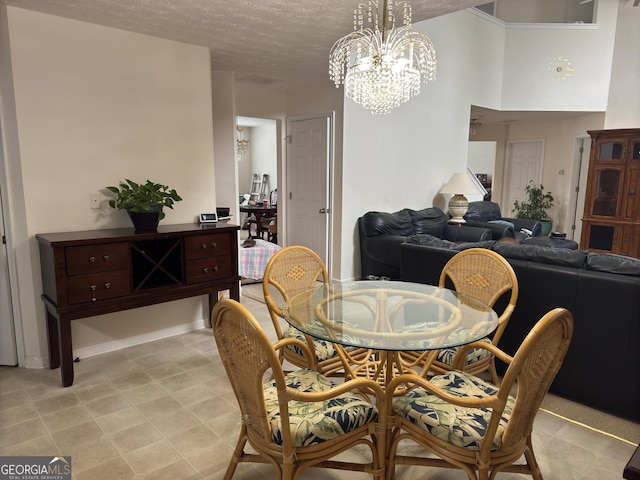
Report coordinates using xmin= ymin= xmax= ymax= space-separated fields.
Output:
xmin=403 ymin=248 xmax=519 ymax=385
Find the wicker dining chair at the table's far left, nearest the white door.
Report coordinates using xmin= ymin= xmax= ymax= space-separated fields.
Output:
xmin=262 ymin=245 xmax=367 ymax=376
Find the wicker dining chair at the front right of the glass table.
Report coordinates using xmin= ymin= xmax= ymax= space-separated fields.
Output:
xmin=386 ymin=308 xmax=573 ymax=480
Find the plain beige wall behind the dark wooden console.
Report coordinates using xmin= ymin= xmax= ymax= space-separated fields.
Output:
xmin=2 ymin=7 xmax=215 ymax=366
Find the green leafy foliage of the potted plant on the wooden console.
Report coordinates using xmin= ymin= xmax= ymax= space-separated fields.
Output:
xmin=105 ymin=178 xmax=182 ymax=220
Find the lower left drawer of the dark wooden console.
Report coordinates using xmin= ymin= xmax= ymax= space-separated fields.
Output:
xmin=67 ymin=270 xmax=131 ymax=304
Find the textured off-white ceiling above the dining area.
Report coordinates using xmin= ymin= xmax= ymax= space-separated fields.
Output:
xmin=0 ymin=0 xmax=488 ymax=87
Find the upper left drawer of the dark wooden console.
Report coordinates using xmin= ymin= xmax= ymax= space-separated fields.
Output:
xmin=65 ymin=243 xmax=129 ymax=275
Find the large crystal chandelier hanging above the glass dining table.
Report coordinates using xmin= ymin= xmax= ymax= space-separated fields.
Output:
xmin=329 ymin=0 xmax=437 ymax=114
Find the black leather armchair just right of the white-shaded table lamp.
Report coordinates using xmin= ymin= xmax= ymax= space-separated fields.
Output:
xmin=464 ymin=201 xmax=542 ymax=242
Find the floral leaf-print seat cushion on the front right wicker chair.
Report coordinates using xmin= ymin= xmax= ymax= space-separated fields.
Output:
xmin=393 ymin=370 xmax=515 ymax=450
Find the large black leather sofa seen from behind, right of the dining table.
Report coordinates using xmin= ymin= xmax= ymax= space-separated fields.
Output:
xmin=400 ymin=236 xmax=640 ymax=422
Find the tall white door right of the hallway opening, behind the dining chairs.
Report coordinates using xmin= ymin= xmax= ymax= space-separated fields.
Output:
xmin=287 ymin=116 xmax=331 ymax=265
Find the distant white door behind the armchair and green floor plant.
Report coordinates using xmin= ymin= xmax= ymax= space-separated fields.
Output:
xmin=500 ymin=140 xmax=544 ymax=217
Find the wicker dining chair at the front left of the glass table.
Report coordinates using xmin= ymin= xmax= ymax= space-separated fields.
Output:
xmin=212 ymin=299 xmax=386 ymax=480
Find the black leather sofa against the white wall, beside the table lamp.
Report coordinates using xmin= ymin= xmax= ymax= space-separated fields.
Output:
xmin=358 ymin=207 xmax=491 ymax=280
